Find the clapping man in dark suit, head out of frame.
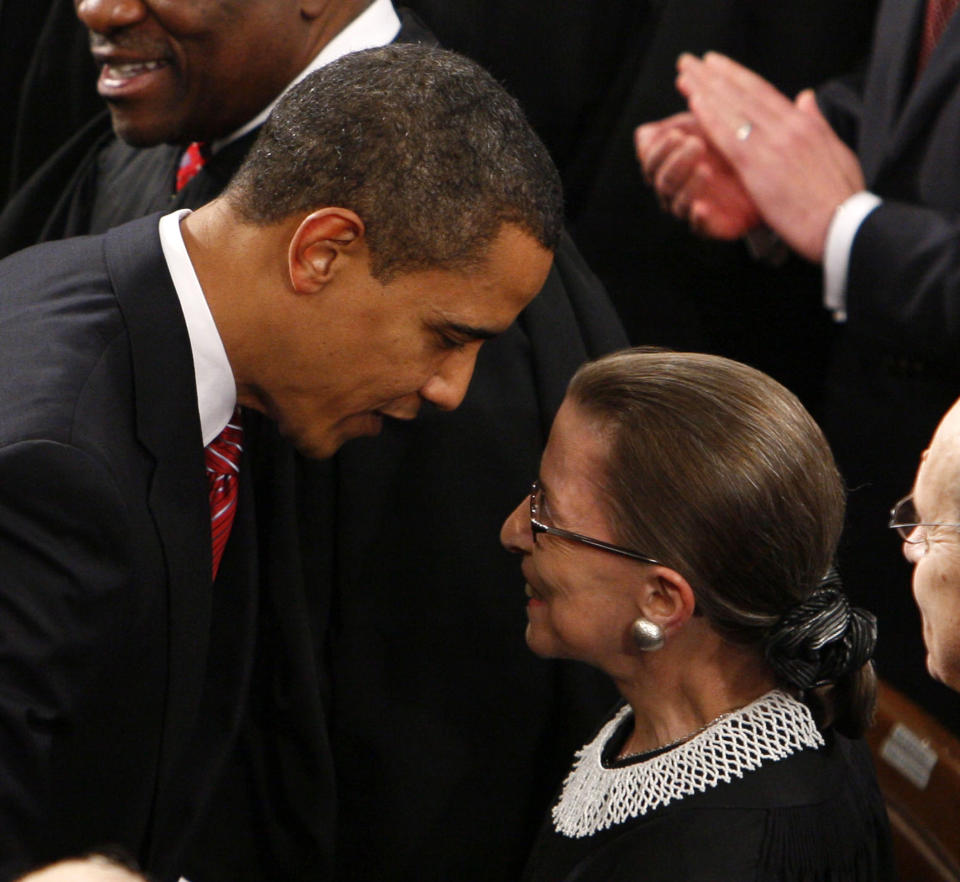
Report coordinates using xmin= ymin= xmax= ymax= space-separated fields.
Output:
xmin=639 ymin=2 xmax=960 ymax=731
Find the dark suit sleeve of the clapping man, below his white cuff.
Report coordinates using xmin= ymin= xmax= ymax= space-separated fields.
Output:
xmin=847 ymin=200 xmax=960 ymax=365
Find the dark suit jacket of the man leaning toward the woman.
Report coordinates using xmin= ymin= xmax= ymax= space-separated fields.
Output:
xmin=0 ymin=217 xmax=256 ymax=879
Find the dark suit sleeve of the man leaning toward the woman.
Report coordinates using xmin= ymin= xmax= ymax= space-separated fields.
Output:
xmin=0 ymin=441 xmax=136 ymax=879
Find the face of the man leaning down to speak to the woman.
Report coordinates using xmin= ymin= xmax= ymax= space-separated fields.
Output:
xmin=240 ymin=225 xmax=552 ymax=458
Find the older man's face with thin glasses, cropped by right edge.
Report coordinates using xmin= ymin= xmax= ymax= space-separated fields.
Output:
xmin=903 ymin=404 xmax=960 ymax=691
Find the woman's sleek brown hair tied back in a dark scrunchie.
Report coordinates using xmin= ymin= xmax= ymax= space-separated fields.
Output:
xmin=568 ymin=349 xmax=876 ymax=735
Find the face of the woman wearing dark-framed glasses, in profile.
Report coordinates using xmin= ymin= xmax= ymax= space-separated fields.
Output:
xmin=500 ymin=399 xmax=644 ymax=674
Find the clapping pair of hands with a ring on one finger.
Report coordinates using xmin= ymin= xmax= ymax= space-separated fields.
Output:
xmin=636 ymin=52 xmax=864 ymax=262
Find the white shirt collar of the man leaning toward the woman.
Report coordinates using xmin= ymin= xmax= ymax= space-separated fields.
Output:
xmin=160 ymin=208 xmax=237 ymax=447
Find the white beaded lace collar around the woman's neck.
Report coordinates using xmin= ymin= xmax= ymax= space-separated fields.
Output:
xmin=553 ymin=689 xmax=824 ymax=839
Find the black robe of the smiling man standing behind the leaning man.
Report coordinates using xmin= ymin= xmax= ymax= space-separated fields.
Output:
xmin=0 ymin=8 xmax=626 ymax=882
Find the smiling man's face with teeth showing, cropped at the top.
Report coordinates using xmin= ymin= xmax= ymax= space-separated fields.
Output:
xmin=75 ymin=0 xmax=316 ymax=147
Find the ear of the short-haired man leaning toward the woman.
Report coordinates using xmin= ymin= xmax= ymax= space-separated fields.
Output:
xmin=287 ymin=208 xmax=366 ymax=294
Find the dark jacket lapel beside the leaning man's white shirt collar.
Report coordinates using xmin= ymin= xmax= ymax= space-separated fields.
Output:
xmin=105 ymin=215 xmax=218 ymax=781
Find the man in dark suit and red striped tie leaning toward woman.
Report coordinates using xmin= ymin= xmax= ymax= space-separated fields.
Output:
xmin=0 ymin=46 xmax=562 ymax=879
